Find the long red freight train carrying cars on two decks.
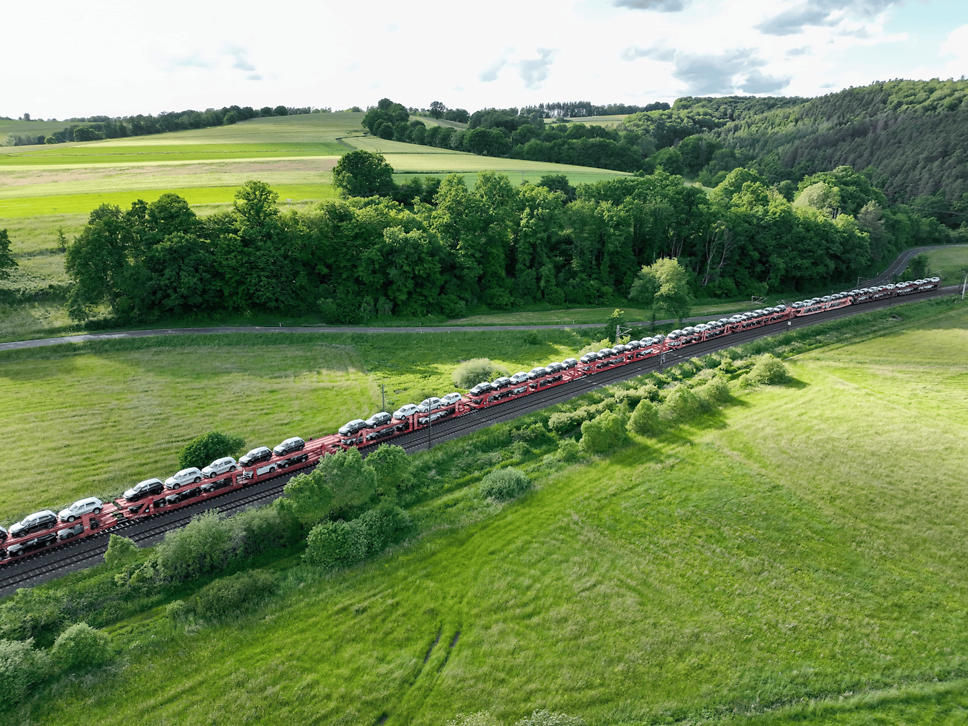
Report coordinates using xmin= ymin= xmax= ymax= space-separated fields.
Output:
xmin=0 ymin=277 xmax=941 ymax=564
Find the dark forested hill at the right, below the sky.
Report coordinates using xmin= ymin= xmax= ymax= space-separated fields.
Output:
xmin=712 ymin=80 xmax=968 ymax=203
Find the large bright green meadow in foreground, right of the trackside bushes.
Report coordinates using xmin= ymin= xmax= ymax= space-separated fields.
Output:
xmin=7 ymin=298 xmax=968 ymax=726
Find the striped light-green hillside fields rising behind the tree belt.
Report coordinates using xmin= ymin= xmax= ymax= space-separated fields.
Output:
xmin=0 ymin=112 xmax=632 ymax=339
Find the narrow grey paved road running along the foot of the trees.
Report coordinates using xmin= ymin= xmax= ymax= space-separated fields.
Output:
xmin=0 ymin=245 xmax=966 ymax=351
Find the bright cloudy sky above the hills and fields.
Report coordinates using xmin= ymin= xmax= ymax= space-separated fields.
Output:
xmin=0 ymin=0 xmax=968 ymax=119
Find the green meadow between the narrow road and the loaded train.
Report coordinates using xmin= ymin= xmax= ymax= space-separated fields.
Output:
xmin=0 ymin=331 xmax=585 ymax=524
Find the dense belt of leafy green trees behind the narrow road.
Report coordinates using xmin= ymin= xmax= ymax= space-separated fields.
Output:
xmin=66 ymin=164 xmax=952 ymax=323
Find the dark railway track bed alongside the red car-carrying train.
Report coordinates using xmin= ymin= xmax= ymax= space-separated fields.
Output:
xmin=0 ymin=285 xmax=961 ymax=597
